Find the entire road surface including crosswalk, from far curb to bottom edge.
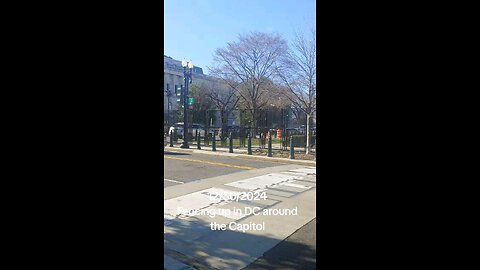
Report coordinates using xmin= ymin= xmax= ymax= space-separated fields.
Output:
xmin=164 ymin=150 xmax=316 ymax=270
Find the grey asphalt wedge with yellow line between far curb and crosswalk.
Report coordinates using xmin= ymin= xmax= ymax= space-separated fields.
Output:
xmin=163 ymin=151 xmax=283 ymax=187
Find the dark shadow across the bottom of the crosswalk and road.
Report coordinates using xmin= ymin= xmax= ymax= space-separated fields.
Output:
xmin=164 ymin=217 xmax=316 ymax=270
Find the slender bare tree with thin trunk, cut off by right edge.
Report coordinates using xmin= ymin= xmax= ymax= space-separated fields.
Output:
xmin=276 ymin=27 xmax=317 ymax=154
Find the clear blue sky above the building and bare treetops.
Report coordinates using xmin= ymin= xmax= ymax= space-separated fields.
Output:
xmin=163 ymin=0 xmax=316 ymax=74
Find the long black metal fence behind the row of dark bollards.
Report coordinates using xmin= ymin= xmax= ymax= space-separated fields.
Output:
xmin=164 ymin=109 xmax=316 ymax=150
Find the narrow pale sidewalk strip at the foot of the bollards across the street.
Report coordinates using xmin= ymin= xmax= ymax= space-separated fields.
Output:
xmin=164 ymin=145 xmax=317 ymax=166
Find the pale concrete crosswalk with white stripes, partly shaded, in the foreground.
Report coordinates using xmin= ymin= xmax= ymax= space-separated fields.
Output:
xmin=164 ymin=165 xmax=316 ymax=269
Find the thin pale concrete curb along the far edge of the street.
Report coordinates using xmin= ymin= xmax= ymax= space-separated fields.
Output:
xmin=164 ymin=146 xmax=317 ymax=166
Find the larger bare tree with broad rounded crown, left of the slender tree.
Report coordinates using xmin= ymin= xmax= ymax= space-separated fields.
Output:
xmin=211 ymin=32 xmax=288 ymax=137
